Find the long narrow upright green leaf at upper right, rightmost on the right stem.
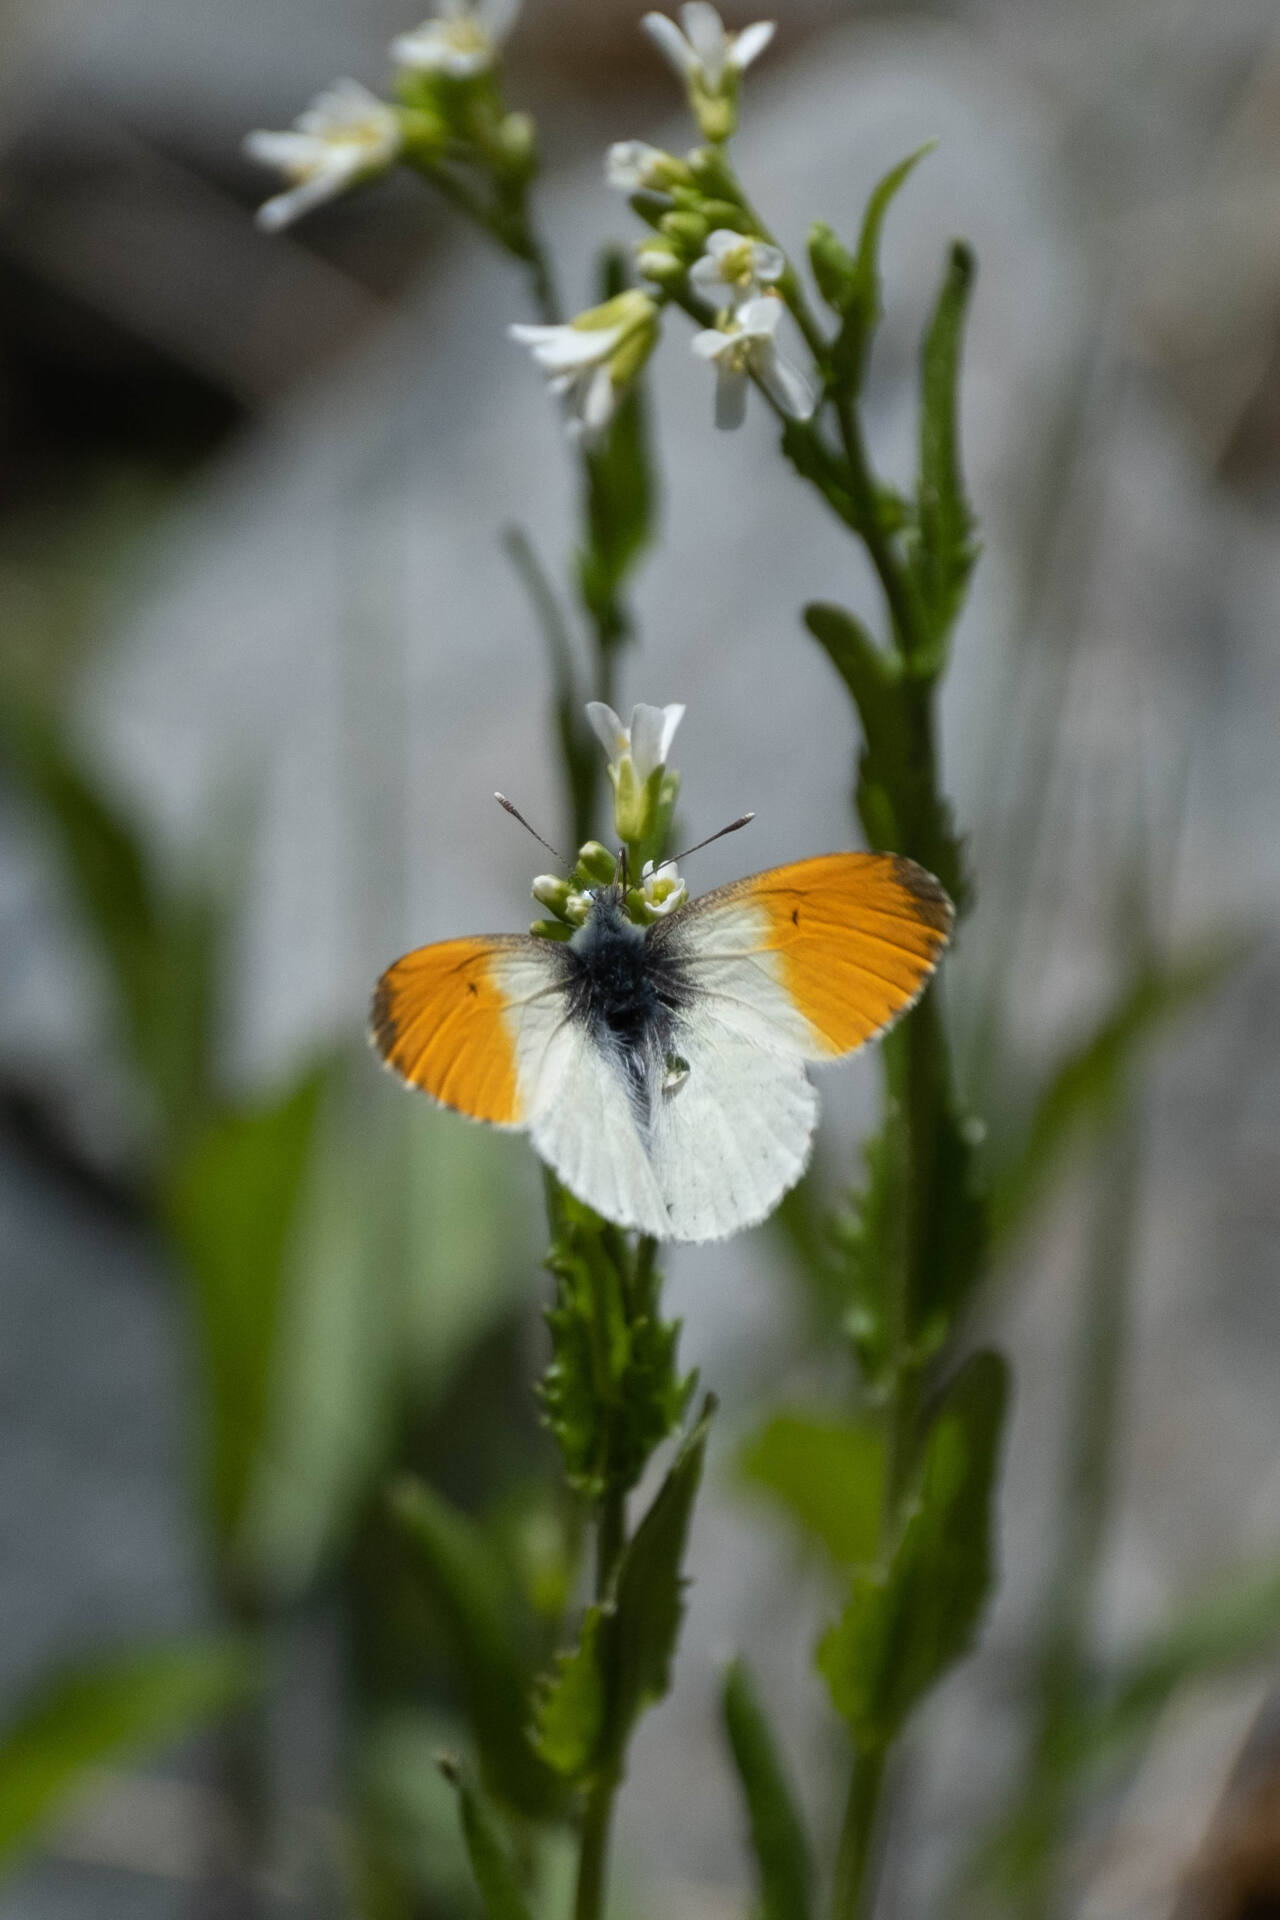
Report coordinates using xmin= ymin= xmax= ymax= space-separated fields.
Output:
xmin=912 ymin=242 xmax=979 ymax=676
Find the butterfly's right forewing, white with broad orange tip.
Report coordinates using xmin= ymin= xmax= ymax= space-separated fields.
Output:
xmin=651 ymin=852 xmax=954 ymax=1060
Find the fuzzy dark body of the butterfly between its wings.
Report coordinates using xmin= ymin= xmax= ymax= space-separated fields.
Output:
xmin=558 ymin=889 xmax=693 ymax=1110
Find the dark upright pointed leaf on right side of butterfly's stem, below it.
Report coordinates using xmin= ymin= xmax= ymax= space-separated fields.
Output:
xmin=608 ymin=1394 xmax=716 ymax=1761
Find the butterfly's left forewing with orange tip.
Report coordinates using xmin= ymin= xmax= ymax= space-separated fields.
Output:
xmin=372 ymin=935 xmax=564 ymax=1127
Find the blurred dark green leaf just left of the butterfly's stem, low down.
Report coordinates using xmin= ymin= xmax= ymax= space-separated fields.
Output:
xmin=391 ymin=1476 xmax=557 ymax=1818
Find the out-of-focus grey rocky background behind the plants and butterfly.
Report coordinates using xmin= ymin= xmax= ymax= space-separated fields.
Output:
xmin=0 ymin=0 xmax=1280 ymax=1920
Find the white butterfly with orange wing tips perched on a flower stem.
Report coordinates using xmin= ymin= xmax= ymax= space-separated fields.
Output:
xmin=372 ymin=852 xmax=954 ymax=1240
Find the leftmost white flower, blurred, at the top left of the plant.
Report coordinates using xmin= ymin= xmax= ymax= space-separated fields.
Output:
xmin=244 ymin=81 xmax=401 ymax=232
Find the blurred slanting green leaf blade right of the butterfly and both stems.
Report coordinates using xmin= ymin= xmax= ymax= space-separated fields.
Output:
xmin=992 ymin=937 xmax=1253 ymax=1238
